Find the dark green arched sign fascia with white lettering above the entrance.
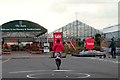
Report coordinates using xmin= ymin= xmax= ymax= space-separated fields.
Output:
xmin=1 ymin=20 xmax=47 ymax=33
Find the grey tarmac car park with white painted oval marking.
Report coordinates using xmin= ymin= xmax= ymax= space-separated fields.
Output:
xmin=2 ymin=52 xmax=119 ymax=79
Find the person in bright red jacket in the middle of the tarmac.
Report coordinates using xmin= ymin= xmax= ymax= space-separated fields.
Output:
xmin=52 ymin=39 xmax=64 ymax=70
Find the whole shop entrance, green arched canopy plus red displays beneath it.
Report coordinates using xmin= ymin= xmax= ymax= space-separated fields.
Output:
xmin=1 ymin=20 xmax=48 ymax=54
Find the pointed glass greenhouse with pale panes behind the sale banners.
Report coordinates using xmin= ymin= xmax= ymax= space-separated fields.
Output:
xmin=48 ymin=20 xmax=102 ymax=41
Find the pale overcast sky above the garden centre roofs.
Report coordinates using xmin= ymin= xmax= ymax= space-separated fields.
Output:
xmin=0 ymin=0 xmax=119 ymax=32
